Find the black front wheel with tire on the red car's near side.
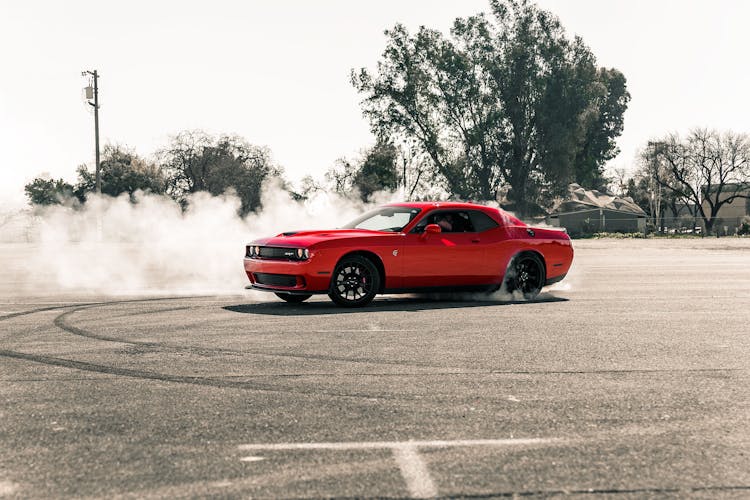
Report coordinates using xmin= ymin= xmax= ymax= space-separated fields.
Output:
xmin=328 ymin=255 xmax=380 ymax=307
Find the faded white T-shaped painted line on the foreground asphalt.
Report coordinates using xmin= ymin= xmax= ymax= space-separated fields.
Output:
xmin=238 ymin=438 xmax=561 ymax=498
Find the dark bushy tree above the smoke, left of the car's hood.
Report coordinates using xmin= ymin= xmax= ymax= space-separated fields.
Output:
xmin=160 ymin=131 xmax=282 ymax=215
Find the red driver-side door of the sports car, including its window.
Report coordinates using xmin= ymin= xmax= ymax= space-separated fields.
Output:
xmin=403 ymin=210 xmax=491 ymax=288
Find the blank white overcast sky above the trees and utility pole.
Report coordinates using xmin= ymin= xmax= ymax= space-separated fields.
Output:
xmin=0 ymin=0 xmax=750 ymax=205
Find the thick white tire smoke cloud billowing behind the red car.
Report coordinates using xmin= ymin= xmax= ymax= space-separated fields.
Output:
xmin=7 ymin=185 xmax=400 ymax=296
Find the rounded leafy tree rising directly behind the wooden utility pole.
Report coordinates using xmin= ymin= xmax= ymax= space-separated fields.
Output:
xmin=75 ymin=144 xmax=167 ymax=201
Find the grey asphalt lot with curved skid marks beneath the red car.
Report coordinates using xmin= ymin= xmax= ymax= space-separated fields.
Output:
xmin=0 ymin=239 xmax=750 ymax=498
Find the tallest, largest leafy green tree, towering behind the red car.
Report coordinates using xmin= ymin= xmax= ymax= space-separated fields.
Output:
xmin=352 ymin=0 xmax=629 ymax=213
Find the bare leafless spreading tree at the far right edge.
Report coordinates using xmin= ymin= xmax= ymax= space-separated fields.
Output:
xmin=643 ymin=129 xmax=750 ymax=233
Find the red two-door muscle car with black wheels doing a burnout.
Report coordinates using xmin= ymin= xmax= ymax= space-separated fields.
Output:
xmin=244 ymin=203 xmax=573 ymax=307
